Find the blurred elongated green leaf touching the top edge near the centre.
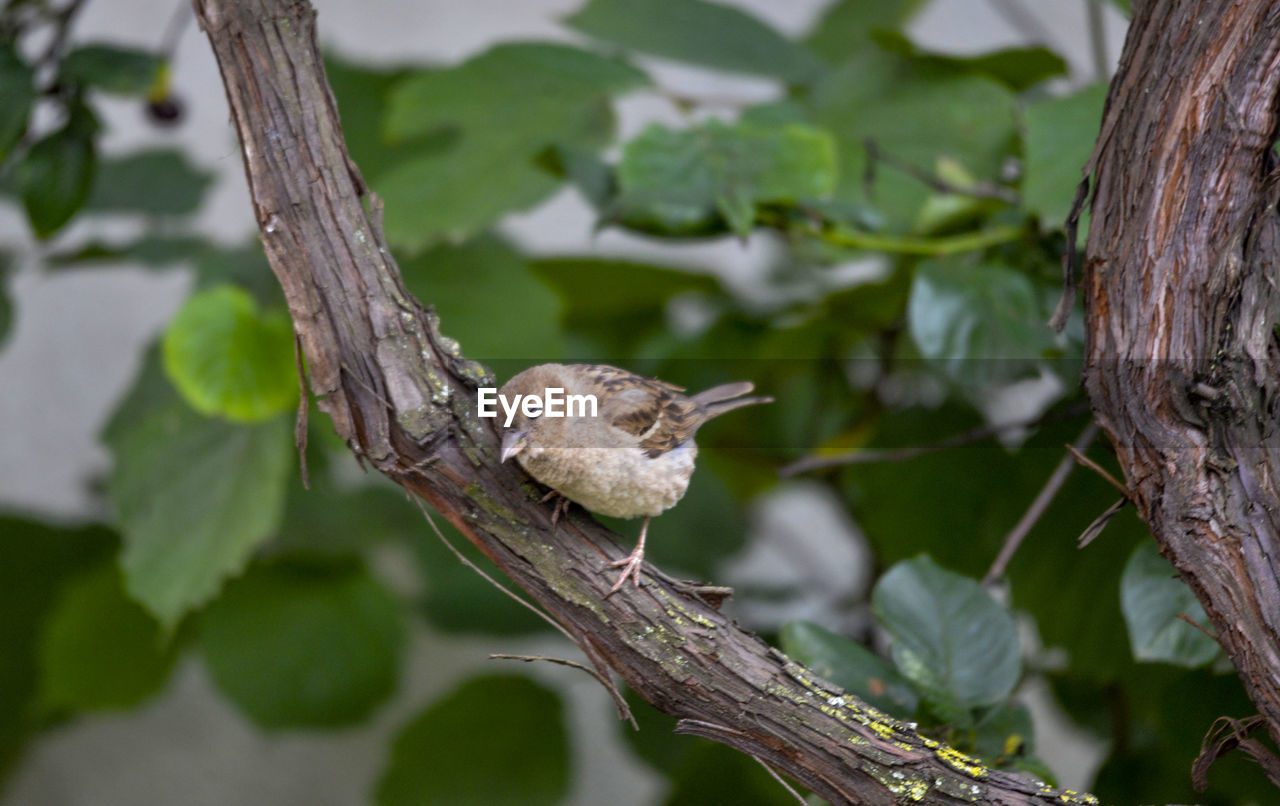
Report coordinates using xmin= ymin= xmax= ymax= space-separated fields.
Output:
xmin=564 ymin=0 xmax=820 ymax=83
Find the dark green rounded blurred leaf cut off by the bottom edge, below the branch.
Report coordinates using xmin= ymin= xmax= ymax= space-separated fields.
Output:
xmin=375 ymin=674 xmax=570 ymax=806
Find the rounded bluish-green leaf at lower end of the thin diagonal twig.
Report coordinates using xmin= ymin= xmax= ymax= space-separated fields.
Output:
xmin=872 ymin=554 xmax=1021 ymax=707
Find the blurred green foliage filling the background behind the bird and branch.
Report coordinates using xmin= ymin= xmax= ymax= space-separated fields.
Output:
xmin=0 ymin=0 xmax=1274 ymax=806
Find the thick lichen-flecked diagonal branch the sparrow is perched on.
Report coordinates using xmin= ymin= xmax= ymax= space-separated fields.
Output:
xmin=195 ymin=0 xmax=1093 ymax=805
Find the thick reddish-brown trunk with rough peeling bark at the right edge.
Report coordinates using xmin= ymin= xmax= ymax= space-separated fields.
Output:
xmin=1084 ymin=0 xmax=1280 ymax=757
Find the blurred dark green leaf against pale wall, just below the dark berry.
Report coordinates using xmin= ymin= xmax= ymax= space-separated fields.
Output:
xmin=84 ymin=148 xmax=214 ymax=215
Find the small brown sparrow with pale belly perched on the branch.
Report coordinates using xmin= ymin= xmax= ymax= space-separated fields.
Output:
xmin=499 ymin=363 xmax=773 ymax=595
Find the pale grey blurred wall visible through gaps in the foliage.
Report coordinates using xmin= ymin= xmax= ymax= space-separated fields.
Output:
xmin=0 ymin=0 xmax=1124 ymax=806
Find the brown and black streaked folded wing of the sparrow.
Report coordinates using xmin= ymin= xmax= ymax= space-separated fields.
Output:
xmin=593 ymin=365 xmax=703 ymax=458
